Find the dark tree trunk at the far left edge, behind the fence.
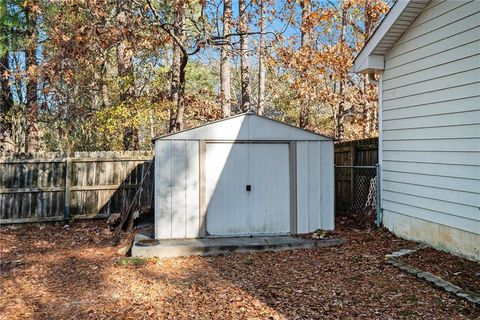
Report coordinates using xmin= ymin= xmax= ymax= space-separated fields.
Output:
xmin=0 ymin=51 xmax=15 ymax=151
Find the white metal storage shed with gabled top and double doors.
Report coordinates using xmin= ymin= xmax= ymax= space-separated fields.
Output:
xmin=154 ymin=113 xmax=334 ymax=239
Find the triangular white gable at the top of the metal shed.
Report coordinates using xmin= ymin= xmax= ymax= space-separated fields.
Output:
xmin=153 ymin=112 xmax=332 ymax=141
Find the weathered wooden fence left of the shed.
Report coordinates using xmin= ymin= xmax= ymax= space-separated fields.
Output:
xmin=0 ymin=151 xmax=153 ymax=224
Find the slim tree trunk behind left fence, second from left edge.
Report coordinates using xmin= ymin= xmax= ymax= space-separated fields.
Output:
xmin=25 ymin=7 xmax=39 ymax=152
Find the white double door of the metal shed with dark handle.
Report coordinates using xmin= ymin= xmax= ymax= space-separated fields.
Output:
xmin=205 ymin=143 xmax=290 ymax=236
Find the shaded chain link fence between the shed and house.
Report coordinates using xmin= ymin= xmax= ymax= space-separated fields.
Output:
xmin=335 ymin=165 xmax=381 ymax=225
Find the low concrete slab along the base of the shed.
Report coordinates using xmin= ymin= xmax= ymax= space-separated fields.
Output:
xmin=132 ymin=233 xmax=345 ymax=258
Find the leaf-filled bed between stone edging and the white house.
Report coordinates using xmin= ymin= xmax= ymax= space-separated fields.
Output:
xmin=399 ymin=248 xmax=480 ymax=294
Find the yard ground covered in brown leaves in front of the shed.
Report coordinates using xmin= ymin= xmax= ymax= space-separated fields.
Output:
xmin=0 ymin=221 xmax=480 ymax=319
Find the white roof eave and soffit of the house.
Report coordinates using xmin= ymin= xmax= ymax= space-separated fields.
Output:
xmin=352 ymin=0 xmax=430 ymax=73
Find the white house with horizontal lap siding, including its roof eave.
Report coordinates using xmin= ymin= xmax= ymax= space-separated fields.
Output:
xmin=353 ymin=0 xmax=480 ymax=259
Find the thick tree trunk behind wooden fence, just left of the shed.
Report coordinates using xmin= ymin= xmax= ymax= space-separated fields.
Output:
xmin=116 ymin=0 xmax=139 ymax=150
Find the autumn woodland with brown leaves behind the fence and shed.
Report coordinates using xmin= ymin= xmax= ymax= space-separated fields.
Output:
xmin=0 ymin=0 xmax=389 ymax=152
